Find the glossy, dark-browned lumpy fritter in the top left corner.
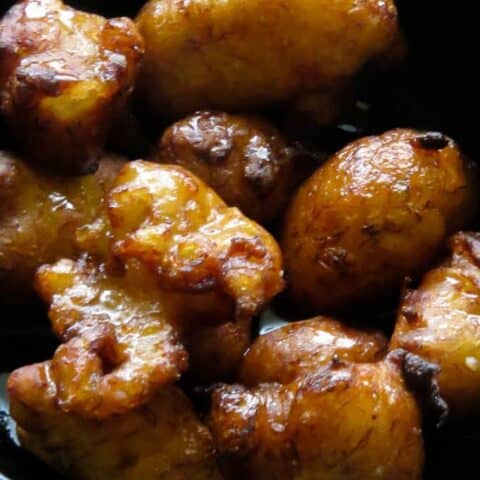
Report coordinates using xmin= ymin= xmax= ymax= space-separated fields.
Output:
xmin=0 ymin=0 xmax=143 ymax=173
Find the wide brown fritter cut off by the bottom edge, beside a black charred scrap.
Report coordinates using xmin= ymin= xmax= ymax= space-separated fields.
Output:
xmin=209 ymin=352 xmax=424 ymax=480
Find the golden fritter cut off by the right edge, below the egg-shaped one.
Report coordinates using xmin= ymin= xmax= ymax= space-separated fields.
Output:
xmin=392 ymin=233 xmax=480 ymax=415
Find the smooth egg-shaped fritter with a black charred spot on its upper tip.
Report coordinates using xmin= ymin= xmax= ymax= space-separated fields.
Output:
xmin=283 ymin=129 xmax=477 ymax=311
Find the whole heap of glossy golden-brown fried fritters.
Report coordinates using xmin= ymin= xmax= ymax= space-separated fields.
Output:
xmin=0 ymin=0 xmax=480 ymax=480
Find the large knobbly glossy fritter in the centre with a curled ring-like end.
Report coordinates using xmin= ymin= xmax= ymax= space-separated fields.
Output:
xmin=8 ymin=161 xmax=283 ymax=419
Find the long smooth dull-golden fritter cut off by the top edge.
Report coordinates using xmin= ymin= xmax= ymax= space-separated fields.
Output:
xmin=137 ymin=0 xmax=398 ymax=116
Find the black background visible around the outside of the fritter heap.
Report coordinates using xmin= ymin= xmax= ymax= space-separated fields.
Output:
xmin=0 ymin=0 xmax=480 ymax=480
